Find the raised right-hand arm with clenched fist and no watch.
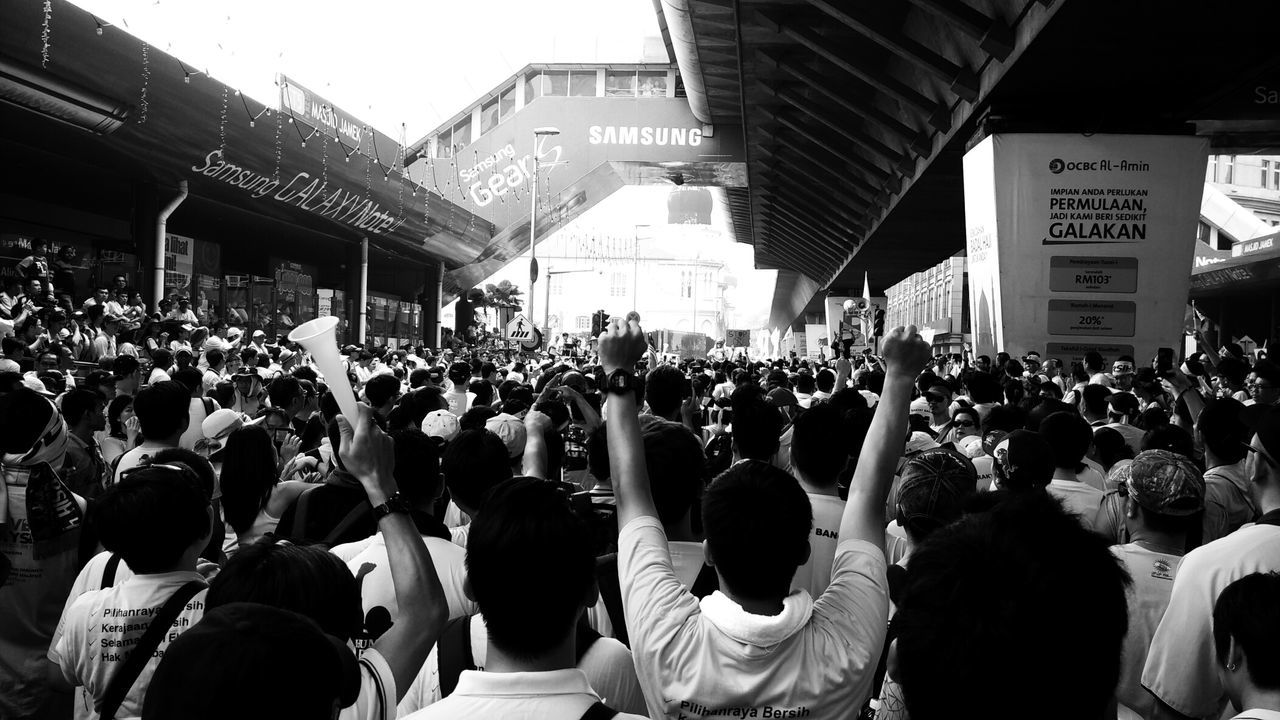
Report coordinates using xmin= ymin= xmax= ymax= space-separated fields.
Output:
xmin=834 ymin=325 xmax=931 ymax=548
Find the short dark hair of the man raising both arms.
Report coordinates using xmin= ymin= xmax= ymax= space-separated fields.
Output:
xmin=703 ymin=458 xmax=813 ymax=600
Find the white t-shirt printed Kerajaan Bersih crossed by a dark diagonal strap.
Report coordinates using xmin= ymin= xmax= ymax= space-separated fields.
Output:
xmin=49 ymin=571 xmax=207 ymax=720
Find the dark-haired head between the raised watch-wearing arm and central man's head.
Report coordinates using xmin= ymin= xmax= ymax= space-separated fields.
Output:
xmin=640 ymin=420 xmax=705 ymax=528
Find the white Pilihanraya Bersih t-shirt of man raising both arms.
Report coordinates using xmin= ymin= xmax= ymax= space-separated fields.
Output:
xmin=618 ymin=516 xmax=888 ymax=720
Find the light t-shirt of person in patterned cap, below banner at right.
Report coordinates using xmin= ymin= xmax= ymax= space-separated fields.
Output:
xmin=1111 ymin=542 xmax=1183 ymax=720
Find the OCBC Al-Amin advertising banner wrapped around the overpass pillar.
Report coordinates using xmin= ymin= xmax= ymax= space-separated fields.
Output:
xmin=964 ymin=133 xmax=1208 ymax=364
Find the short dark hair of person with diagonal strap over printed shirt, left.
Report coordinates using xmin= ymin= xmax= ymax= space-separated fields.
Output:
xmin=88 ymin=468 xmax=210 ymax=574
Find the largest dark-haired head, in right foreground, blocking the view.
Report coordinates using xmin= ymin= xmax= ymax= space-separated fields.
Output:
xmin=892 ymin=493 xmax=1129 ymax=720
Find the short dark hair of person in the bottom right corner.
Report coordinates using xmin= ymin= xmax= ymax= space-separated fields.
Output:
xmin=1213 ymin=573 xmax=1280 ymax=692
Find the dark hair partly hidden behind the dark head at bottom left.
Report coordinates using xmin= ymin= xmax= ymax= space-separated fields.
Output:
xmin=206 ymin=537 xmax=364 ymax=642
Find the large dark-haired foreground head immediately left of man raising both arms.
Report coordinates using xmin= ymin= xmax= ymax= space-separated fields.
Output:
xmin=466 ymin=477 xmax=596 ymax=660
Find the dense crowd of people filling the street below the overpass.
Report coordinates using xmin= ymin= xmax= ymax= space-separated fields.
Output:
xmin=0 ymin=293 xmax=1280 ymax=720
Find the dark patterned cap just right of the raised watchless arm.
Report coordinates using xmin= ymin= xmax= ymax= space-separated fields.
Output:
xmin=897 ymin=447 xmax=978 ymax=529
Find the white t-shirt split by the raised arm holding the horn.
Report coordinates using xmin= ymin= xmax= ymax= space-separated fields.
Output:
xmin=332 ymin=533 xmax=480 ymax=621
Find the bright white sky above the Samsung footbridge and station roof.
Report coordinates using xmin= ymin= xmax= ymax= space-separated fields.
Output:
xmin=72 ymin=0 xmax=659 ymax=142
